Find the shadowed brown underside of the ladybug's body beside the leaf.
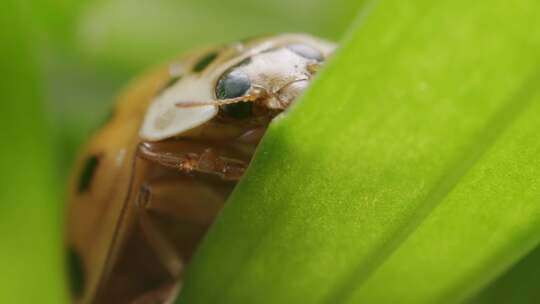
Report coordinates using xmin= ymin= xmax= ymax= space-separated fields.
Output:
xmin=98 ymin=140 xmax=255 ymax=303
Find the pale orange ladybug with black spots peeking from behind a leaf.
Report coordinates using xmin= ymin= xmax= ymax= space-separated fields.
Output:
xmin=66 ymin=34 xmax=336 ymax=304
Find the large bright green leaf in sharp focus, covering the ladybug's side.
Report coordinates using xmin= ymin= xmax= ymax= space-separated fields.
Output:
xmin=179 ymin=0 xmax=540 ymax=304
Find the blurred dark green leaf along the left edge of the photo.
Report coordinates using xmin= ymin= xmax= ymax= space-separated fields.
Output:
xmin=0 ymin=0 xmax=65 ymax=304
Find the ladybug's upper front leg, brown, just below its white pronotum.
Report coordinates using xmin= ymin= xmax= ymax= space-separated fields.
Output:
xmin=138 ymin=143 xmax=248 ymax=181
